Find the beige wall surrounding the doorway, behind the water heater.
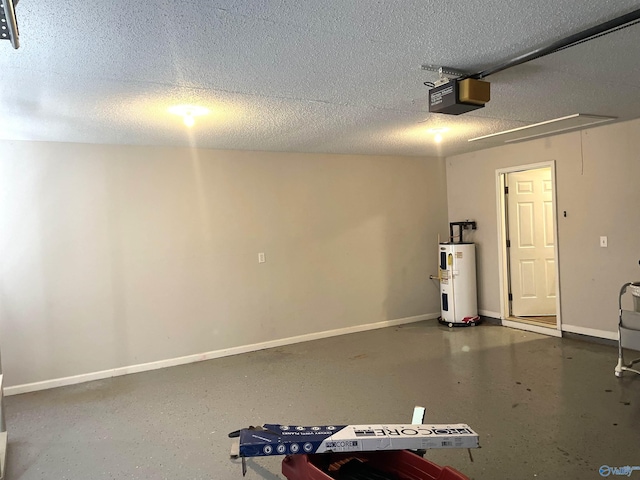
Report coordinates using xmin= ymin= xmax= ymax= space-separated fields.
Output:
xmin=447 ymin=120 xmax=640 ymax=337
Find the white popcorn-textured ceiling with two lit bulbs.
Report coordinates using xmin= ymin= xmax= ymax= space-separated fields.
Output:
xmin=0 ymin=0 xmax=640 ymax=155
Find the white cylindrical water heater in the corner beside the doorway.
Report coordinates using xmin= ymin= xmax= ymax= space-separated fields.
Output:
xmin=438 ymin=243 xmax=480 ymax=327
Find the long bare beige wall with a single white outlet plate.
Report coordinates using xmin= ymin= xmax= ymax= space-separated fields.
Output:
xmin=0 ymin=141 xmax=447 ymax=386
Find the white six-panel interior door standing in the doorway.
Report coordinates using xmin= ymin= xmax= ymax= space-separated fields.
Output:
xmin=507 ymin=167 xmax=556 ymax=317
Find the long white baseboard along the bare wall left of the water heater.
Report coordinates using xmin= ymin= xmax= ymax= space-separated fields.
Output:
xmin=4 ymin=312 xmax=440 ymax=395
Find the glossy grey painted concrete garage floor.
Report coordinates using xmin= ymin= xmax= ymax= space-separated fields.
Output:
xmin=5 ymin=321 xmax=640 ymax=480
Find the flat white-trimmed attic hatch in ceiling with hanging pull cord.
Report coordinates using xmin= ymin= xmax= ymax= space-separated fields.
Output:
xmin=468 ymin=113 xmax=618 ymax=143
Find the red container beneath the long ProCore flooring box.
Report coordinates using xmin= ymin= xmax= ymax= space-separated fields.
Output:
xmin=282 ymin=450 xmax=469 ymax=480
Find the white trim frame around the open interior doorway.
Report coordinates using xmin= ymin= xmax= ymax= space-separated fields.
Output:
xmin=496 ymin=160 xmax=562 ymax=337
